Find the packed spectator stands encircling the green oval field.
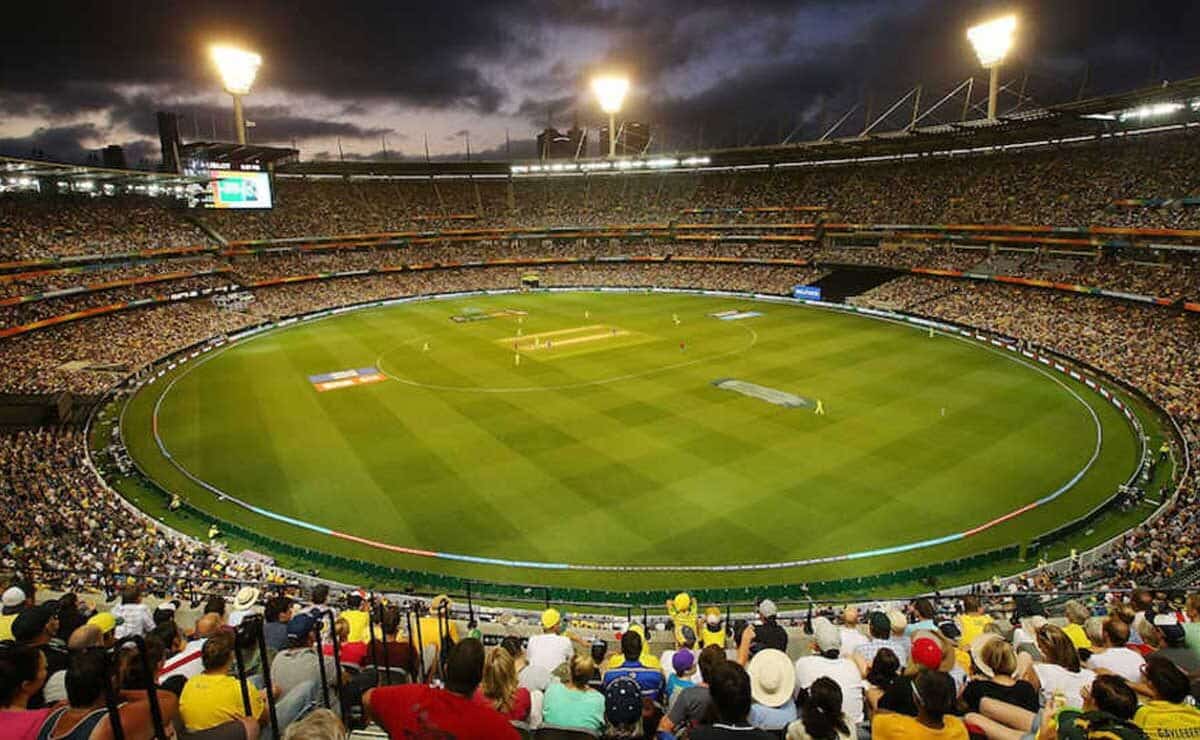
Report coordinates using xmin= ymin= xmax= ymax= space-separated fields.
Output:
xmin=0 ymin=119 xmax=1200 ymax=740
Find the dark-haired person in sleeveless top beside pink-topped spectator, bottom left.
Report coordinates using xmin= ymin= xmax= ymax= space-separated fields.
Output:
xmin=40 ymin=650 xmax=179 ymax=740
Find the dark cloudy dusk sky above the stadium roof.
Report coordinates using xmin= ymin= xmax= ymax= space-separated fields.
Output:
xmin=0 ymin=0 xmax=1200 ymax=163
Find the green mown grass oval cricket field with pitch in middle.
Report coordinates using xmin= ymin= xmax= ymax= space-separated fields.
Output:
xmin=122 ymin=291 xmax=1150 ymax=590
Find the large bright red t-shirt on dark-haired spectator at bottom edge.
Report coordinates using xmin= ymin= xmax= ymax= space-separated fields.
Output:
xmin=371 ymin=684 xmax=521 ymax=740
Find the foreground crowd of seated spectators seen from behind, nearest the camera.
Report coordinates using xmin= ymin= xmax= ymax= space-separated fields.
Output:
xmin=0 ymin=579 xmax=1200 ymax=740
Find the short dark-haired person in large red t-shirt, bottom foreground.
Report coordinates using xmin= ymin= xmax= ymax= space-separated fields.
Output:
xmin=362 ymin=638 xmax=518 ymax=740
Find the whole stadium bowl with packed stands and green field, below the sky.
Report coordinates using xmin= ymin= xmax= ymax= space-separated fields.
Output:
xmin=0 ymin=20 xmax=1200 ymax=740
